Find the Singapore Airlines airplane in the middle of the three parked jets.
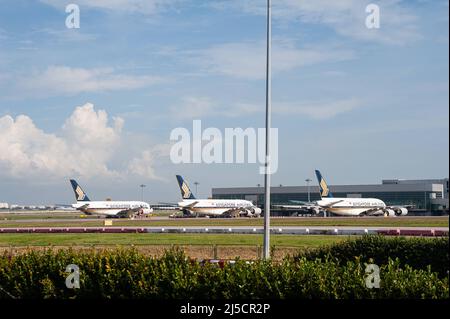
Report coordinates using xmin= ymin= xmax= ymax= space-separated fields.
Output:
xmin=176 ymin=175 xmax=261 ymax=217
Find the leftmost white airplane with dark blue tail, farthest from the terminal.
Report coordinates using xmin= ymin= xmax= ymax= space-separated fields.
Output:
xmin=70 ymin=179 xmax=153 ymax=217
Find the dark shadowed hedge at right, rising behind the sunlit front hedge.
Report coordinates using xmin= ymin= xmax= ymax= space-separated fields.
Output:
xmin=295 ymin=235 xmax=449 ymax=277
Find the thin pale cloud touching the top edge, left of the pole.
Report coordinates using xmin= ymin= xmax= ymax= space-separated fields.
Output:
xmin=41 ymin=0 xmax=181 ymax=15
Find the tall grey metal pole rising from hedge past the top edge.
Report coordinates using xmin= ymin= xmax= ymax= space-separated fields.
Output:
xmin=263 ymin=0 xmax=272 ymax=260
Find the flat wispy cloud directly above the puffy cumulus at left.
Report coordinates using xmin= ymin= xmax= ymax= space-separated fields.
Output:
xmin=18 ymin=66 xmax=162 ymax=96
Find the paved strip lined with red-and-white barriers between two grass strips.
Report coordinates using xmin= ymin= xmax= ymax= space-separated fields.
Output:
xmin=0 ymin=226 xmax=449 ymax=237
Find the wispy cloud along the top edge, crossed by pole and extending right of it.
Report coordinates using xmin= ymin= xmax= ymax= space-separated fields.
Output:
xmin=212 ymin=0 xmax=421 ymax=45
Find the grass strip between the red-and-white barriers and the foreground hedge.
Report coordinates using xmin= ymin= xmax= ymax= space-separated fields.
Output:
xmin=0 ymin=234 xmax=348 ymax=260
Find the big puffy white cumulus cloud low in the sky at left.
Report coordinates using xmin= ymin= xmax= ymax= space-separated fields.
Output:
xmin=0 ymin=103 xmax=165 ymax=178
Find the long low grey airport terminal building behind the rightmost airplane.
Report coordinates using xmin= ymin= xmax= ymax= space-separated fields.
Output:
xmin=212 ymin=178 xmax=449 ymax=215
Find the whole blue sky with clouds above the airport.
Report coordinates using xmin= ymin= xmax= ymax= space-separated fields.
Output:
xmin=0 ymin=0 xmax=449 ymax=203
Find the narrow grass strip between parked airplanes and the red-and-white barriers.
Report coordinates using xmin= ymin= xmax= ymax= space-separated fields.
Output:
xmin=0 ymin=214 xmax=449 ymax=227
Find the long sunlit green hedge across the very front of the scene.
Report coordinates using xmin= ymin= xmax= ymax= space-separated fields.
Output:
xmin=0 ymin=250 xmax=449 ymax=299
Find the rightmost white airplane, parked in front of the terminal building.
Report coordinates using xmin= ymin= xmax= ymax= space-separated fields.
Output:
xmin=279 ymin=170 xmax=408 ymax=217
